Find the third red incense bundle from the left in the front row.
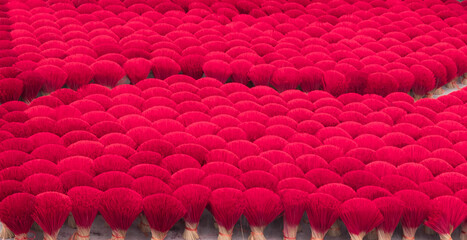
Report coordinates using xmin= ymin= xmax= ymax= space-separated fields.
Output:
xmin=68 ymin=186 xmax=102 ymax=240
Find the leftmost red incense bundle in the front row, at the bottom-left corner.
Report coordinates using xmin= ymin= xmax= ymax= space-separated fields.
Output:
xmin=0 ymin=193 xmax=34 ymax=240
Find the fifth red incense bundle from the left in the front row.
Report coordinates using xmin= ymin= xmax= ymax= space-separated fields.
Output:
xmin=143 ymin=194 xmax=186 ymax=240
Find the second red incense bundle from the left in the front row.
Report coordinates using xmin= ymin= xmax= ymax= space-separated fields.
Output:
xmin=32 ymin=192 xmax=71 ymax=240
